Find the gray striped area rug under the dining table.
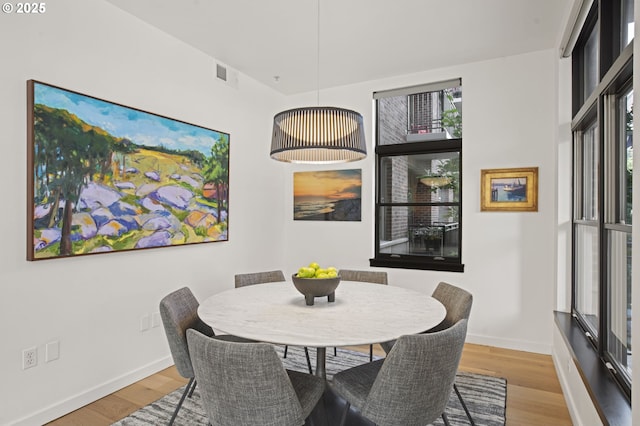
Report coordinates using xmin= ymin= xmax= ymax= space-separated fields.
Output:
xmin=114 ymin=346 xmax=507 ymax=426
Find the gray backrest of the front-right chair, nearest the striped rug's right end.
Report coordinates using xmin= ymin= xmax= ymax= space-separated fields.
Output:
xmin=362 ymin=320 xmax=467 ymax=425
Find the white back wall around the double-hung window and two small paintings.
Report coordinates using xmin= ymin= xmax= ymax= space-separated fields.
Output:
xmin=284 ymin=50 xmax=557 ymax=353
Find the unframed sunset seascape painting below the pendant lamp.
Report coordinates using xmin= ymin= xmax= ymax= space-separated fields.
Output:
xmin=293 ymin=169 xmax=362 ymax=221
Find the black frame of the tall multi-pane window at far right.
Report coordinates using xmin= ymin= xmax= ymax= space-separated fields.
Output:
xmin=571 ymin=0 xmax=638 ymax=401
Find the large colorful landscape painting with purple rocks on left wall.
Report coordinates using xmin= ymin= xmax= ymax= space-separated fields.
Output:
xmin=27 ymin=80 xmax=229 ymax=260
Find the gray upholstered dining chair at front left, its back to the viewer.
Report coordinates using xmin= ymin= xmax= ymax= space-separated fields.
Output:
xmin=187 ymin=330 xmax=325 ymax=426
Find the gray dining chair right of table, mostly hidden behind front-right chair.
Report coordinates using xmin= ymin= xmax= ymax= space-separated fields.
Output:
xmin=380 ymin=281 xmax=475 ymax=425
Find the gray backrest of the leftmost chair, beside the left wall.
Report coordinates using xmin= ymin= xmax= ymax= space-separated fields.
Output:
xmin=160 ymin=287 xmax=214 ymax=379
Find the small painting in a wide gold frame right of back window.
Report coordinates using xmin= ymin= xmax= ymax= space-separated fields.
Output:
xmin=480 ymin=167 xmax=538 ymax=212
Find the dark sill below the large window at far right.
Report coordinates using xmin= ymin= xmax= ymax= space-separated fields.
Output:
xmin=554 ymin=311 xmax=631 ymax=425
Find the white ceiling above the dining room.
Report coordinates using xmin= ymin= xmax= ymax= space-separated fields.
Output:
xmin=107 ymin=0 xmax=573 ymax=95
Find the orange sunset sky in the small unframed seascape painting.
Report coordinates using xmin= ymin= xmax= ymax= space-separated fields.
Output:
xmin=293 ymin=169 xmax=362 ymax=202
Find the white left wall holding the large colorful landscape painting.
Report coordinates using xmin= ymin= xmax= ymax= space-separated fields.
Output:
xmin=0 ymin=0 xmax=286 ymax=424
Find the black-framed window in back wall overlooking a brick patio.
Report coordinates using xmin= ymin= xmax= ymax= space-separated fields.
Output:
xmin=371 ymin=79 xmax=464 ymax=272
